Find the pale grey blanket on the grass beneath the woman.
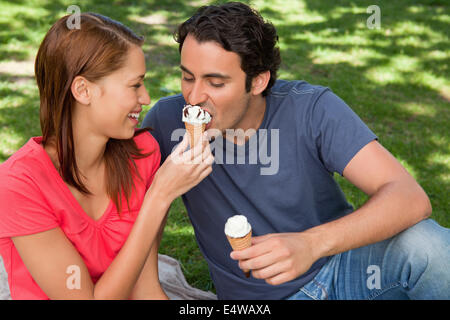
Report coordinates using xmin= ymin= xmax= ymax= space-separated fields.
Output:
xmin=0 ymin=254 xmax=217 ymax=300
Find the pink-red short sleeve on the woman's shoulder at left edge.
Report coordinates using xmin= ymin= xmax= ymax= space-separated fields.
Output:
xmin=0 ymin=176 xmax=59 ymax=238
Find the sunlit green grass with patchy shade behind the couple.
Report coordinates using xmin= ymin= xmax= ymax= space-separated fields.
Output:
xmin=0 ymin=0 xmax=450 ymax=291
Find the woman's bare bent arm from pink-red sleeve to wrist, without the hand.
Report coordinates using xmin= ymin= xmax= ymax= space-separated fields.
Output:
xmin=12 ymin=188 xmax=169 ymax=300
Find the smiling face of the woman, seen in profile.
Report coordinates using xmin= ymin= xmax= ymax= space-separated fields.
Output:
xmin=87 ymin=46 xmax=150 ymax=139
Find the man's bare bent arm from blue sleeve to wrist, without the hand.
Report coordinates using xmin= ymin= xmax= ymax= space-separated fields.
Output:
xmin=308 ymin=141 xmax=432 ymax=257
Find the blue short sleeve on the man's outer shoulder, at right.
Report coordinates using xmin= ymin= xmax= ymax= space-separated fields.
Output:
xmin=311 ymin=89 xmax=378 ymax=176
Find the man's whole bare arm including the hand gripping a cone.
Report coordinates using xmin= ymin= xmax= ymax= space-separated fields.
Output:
xmin=231 ymin=140 xmax=432 ymax=285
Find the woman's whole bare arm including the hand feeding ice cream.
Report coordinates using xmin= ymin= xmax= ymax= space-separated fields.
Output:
xmin=12 ymin=137 xmax=214 ymax=299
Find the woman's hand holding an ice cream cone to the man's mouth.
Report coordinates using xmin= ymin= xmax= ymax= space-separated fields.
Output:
xmin=148 ymin=133 xmax=214 ymax=202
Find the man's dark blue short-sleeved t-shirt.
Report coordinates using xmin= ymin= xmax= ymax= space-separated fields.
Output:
xmin=143 ymin=80 xmax=377 ymax=300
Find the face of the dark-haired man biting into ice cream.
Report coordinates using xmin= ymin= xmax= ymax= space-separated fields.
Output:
xmin=180 ymin=35 xmax=252 ymax=132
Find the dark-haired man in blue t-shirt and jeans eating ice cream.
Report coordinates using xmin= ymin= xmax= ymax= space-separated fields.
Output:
xmin=143 ymin=3 xmax=450 ymax=299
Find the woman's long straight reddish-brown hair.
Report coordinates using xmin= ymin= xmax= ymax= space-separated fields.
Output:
xmin=35 ymin=13 xmax=151 ymax=213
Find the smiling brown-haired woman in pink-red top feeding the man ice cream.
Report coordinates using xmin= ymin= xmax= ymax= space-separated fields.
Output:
xmin=0 ymin=13 xmax=213 ymax=299
